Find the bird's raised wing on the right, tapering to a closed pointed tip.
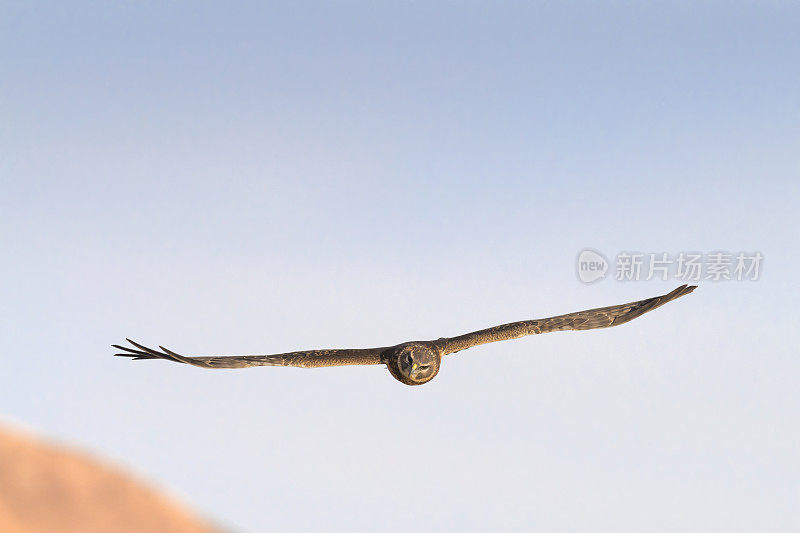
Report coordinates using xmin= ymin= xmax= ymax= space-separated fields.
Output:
xmin=439 ymin=285 xmax=697 ymax=355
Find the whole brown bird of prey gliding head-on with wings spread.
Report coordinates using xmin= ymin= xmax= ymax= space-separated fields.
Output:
xmin=112 ymin=285 xmax=696 ymax=385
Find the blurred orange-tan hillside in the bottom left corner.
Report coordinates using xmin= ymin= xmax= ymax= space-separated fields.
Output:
xmin=0 ymin=427 xmax=215 ymax=533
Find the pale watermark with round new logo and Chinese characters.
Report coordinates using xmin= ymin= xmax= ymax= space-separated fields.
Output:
xmin=577 ymin=248 xmax=764 ymax=283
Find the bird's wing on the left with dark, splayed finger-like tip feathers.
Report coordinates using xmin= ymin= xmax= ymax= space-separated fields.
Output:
xmin=112 ymin=339 xmax=386 ymax=368
